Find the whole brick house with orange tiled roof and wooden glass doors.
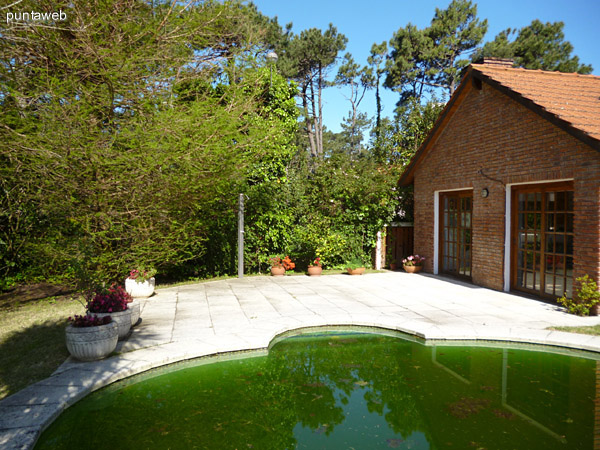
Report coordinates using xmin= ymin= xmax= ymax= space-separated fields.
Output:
xmin=399 ymin=59 xmax=600 ymax=299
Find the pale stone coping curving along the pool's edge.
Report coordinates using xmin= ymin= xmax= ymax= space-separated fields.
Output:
xmin=0 ymin=321 xmax=600 ymax=449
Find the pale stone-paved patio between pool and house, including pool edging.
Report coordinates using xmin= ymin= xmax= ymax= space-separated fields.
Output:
xmin=0 ymin=272 xmax=600 ymax=449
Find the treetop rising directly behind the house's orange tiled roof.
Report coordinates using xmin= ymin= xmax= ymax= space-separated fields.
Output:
xmin=473 ymin=19 xmax=592 ymax=74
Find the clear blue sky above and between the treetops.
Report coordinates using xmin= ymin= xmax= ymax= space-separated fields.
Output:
xmin=254 ymin=0 xmax=600 ymax=132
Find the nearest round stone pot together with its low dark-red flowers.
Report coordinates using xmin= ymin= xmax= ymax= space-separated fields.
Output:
xmin=65 ymin=314 xmax=119 ymax=361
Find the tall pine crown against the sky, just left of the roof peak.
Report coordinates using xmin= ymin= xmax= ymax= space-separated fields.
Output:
xmin=384 ymin=0 xmax=487 ymax=104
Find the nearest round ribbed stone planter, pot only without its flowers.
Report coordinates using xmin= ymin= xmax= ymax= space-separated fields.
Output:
xmin=65 ymin=321 xmax=119 ymax=361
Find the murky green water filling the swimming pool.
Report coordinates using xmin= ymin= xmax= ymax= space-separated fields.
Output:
xmin=36 ymin=332 xmax=600 ymax=450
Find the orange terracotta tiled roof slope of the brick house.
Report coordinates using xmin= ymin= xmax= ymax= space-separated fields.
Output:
xmin=471 ymin=64 xmax=600 ymax=141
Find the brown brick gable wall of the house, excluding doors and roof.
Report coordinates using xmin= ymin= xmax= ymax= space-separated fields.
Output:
xmin=414 ymin=83 xmax=600 ymax=290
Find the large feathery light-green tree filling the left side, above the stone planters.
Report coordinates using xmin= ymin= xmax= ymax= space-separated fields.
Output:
xmin=0 ymin=0 xmax=296 ymax=281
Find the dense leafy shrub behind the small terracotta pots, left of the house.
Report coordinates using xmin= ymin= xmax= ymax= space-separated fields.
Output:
xmin=290 ymin=152 xmax=398 ymax=268
